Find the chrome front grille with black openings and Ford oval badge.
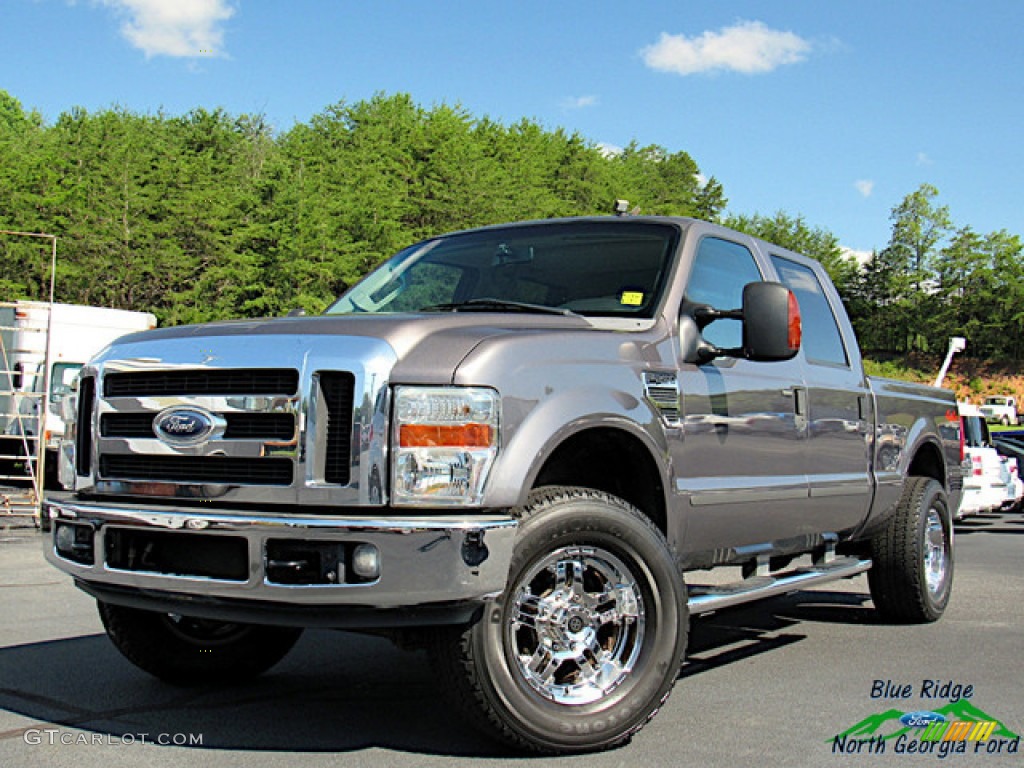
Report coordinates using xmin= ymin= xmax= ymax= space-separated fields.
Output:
xmin=65 ymin=331 xmax=396 ymax=510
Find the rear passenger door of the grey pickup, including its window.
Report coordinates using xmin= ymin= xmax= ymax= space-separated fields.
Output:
xmin=771 ymin=253 xmax=871 ymax=531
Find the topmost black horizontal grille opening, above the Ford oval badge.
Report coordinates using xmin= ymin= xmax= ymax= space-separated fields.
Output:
xmin=103 ymin=368 xmax=299 ymax=397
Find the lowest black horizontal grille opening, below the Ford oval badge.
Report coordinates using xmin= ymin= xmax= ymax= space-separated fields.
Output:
xmin=99 ymin=455 xmax=294 ymax=485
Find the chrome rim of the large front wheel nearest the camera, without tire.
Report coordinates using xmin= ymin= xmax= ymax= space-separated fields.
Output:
xmin=506 ymin=547 xmax=646 ymax=706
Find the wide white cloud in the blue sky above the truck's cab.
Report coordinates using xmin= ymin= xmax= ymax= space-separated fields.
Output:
xmin=640 ymin=22 xmax=811 ymax=75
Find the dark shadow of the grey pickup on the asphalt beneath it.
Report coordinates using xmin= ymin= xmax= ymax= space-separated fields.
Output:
xmin=0 ymin=592 xmax=869 ymax=758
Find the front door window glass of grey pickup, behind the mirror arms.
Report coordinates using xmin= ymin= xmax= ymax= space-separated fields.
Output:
xmin=686 ymin=238 xmax=762 ymax=349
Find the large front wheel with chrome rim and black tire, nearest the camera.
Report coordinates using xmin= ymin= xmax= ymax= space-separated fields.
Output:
xmin=434 ymin=487 xmax=687 ymax=753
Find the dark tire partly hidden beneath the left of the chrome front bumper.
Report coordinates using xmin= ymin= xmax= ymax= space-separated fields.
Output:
xmin=98 ymin=602 xmax=302 ymax=685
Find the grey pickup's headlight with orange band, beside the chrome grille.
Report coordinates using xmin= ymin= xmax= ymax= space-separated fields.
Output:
xmin=391 ymin=386 xmax=500 ymax=506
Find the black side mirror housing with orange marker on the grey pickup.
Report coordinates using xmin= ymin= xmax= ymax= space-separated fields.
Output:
xmin=743 ymin=283 xmax=803 ymax=362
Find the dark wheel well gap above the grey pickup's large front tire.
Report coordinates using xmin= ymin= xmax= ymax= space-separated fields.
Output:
xmin=534 ymin=428 xmax=668 ymax=534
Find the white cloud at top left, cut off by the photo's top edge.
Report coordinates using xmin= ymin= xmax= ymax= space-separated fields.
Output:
xmin=101 ymin=0 xmax=234 ymax=58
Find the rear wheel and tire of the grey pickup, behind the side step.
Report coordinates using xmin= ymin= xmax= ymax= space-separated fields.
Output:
xmin=867 ymin=477 xmax=953 ymax=624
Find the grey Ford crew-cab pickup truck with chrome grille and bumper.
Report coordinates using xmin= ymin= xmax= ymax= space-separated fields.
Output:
xmin=44 ymin=216 xmax=962 ymax=753
